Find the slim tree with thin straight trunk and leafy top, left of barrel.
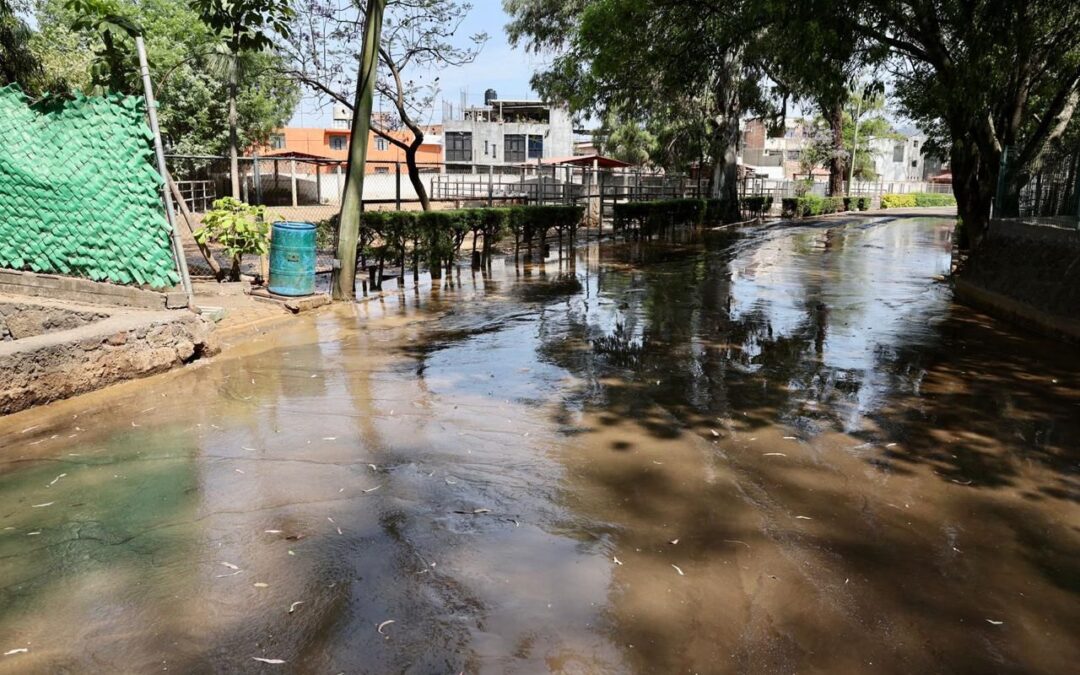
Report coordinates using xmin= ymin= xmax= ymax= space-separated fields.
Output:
xmin=192 ymin=0 xmax=294 ymax=199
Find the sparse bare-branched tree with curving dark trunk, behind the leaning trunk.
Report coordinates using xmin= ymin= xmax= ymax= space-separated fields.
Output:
xmin=282 ymin=0 xmax=487 ymax=211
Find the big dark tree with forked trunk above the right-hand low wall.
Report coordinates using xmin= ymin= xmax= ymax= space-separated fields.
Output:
xmin=846 ymin=0 xmax=1080 ymax=245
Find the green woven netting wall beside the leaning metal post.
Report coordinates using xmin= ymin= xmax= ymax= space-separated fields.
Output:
xmin=0 ymin=85 xmax=179 ymax=288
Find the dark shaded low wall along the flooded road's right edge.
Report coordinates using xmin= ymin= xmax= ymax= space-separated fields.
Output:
xmin=958 ymin=220 xmax=1080 ymax=338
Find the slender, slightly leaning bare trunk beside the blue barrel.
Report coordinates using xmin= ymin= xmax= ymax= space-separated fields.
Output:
xmin=333 ymin=0 xmax=387 ymax=300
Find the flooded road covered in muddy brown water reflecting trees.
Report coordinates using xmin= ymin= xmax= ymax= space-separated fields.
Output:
xmin=0 ymin=219 xmax=1080 ymax=673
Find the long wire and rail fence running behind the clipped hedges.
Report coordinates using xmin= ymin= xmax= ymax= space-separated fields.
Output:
xmin=167 ymin=153 xmax=950 ymax=278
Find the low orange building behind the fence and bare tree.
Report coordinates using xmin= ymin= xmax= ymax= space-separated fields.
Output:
xmin=258 ymin=126 xmax=443 ymax=174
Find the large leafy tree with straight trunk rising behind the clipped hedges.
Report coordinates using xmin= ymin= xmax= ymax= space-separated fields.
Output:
xmin=503 ymin=0 xmax=767 ymax=219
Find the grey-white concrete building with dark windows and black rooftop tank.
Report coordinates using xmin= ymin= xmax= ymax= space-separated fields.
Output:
xmin=443 ymin=90 xmax=573 ymax=173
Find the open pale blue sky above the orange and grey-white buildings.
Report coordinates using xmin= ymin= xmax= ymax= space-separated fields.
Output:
xmin=292 ymin=0 xmax=545 ymax=126
